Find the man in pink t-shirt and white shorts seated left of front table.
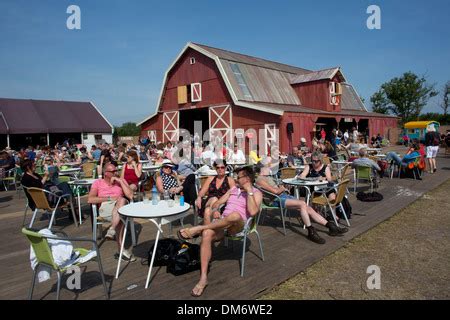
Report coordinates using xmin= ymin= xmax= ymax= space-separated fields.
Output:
xmin=88 ymin=162 xmax=136 ymax=261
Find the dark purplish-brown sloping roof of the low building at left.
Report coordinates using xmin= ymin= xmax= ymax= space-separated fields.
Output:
xmin=0 ymin=98 xmax=112 ymax=134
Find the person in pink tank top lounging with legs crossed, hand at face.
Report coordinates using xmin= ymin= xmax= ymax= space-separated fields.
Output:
xmin=178 ymin=167 xmax=262 ymax=297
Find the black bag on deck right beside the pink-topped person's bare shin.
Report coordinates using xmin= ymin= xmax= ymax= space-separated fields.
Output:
xmin=167 ymin=242 xmax=200 ymax=276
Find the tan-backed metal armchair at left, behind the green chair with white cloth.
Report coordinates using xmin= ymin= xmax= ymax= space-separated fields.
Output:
xmin=24 ymin=187 xmax=78 ymax=229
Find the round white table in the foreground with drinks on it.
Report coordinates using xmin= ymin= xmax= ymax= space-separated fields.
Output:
xmin=116 ymin=200 xmax=191 ymax=289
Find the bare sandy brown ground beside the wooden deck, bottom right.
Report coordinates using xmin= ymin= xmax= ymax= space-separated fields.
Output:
xmin=261 ymin=180 xmax=450 ymax=300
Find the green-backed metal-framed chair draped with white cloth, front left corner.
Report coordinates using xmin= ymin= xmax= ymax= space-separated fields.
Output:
xmin=22 ymin=228 xmax=109 ymax=300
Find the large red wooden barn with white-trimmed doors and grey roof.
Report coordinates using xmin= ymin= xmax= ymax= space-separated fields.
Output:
xmin=138 ymin=43 xmax=397 ymax=152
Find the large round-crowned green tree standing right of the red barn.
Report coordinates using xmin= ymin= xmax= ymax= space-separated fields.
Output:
xmin=374 ymin=72 xmax=438 ymax=123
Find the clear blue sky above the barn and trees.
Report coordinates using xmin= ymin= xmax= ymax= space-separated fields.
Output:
xmin=0 ymin=0 xmax=450 ymax=124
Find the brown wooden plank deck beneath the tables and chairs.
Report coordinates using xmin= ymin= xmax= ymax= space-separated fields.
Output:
xmin=0 ymin=153 xmax=450 ymax=300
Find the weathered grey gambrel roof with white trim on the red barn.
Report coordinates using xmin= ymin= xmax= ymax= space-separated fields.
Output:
xmin=137 ymin=42 xmax=380 ymax=125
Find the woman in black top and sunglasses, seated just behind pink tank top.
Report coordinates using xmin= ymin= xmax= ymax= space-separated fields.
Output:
xmin=195 ymin=160 xmax=235 ymax=224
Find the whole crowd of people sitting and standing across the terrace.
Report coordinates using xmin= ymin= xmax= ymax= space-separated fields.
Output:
xmin=0 ymin=129 xmax=446 ymax=297
